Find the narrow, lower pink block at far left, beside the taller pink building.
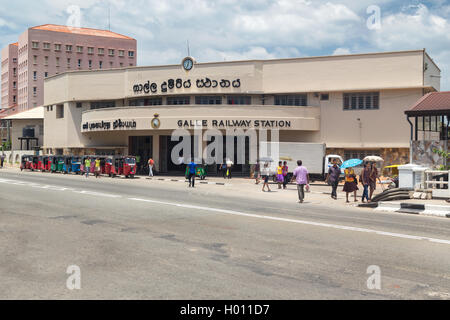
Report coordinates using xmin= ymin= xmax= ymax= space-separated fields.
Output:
xmin=1 ymin=43 xmax=18 ymax=109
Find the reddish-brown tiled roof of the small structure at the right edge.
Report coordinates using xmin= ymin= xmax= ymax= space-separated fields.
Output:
xmin=405 ymin=91 xmax=450 ymax=116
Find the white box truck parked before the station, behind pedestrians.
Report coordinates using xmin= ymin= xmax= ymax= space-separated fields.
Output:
xmin=260 ymin=142 xmax=344 ymax=182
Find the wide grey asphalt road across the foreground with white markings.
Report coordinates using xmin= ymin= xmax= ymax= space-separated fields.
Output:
xmin=0 ymin=170 xmax=450 ymax=299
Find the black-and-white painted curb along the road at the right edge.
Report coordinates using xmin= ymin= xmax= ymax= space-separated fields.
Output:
xmin=358 ymin=201 xmax=450 ymax=218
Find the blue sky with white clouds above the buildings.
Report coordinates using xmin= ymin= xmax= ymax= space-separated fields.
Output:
xmin=0 ymin=0 xmax=450 ymax=90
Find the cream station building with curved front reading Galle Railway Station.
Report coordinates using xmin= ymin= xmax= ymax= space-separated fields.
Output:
xmin=43 ymin=50 xmax=440 ymax=173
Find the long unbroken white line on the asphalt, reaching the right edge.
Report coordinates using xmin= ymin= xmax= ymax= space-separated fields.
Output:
xmin=128 ymin=198 xmax=450 ymax=245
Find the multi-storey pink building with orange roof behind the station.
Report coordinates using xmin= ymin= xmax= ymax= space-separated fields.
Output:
xmin=2 ymin=24 xmax=137 ymax=111
